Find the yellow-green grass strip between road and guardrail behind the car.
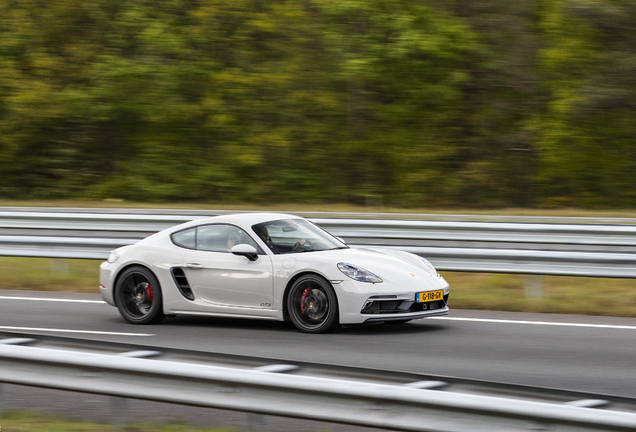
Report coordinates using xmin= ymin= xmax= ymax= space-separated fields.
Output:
xmin=0 ymin=257 xmax=636 ymax=317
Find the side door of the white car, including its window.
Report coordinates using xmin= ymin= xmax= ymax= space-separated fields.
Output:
xmin=183 ymin=224 xmax=273 ymax=309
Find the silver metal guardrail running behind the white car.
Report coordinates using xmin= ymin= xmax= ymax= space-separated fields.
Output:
xmin=0 ymin=207 xmax=636 ymax=278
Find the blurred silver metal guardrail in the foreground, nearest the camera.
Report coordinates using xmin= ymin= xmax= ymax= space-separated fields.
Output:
xmin=0 ymin=340 xmax=636 ymax=432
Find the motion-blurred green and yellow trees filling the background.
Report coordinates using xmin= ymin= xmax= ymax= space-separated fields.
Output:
xmin=0 ymin=0 xmax=636 ymax=207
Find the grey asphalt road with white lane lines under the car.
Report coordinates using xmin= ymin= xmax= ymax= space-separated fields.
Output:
xmin=0 ymin=291 xmax=636 ymax=397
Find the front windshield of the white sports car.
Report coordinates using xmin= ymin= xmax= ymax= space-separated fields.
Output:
xmin=252 ymin=219 xmax=348 ymax=254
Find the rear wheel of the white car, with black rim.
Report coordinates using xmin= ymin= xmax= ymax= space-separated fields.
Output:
xmin=115 ymin=266 xmax=164 ymax=324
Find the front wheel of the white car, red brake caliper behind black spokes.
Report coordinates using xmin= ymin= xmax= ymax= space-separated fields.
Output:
xmin=287 ymin=275 xmax=338 ymax=333
